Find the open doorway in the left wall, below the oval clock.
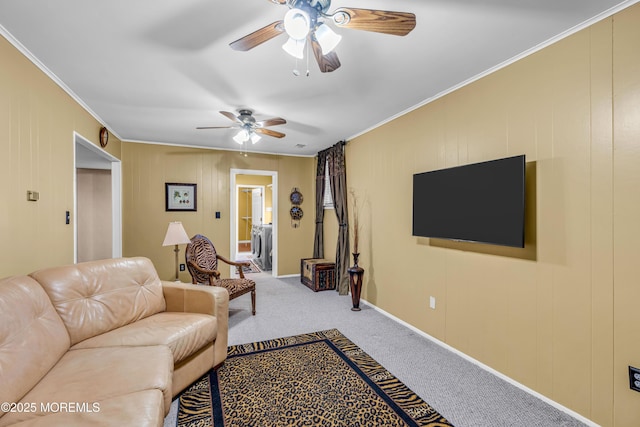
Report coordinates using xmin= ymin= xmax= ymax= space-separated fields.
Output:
xmin=73 ymin=133 xmax=122 ymax=263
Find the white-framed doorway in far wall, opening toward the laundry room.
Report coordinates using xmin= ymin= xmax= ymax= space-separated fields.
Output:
xmin=229 ymin=169 xmax=278 ymax=276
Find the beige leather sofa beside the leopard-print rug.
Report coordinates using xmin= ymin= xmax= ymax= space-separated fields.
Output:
xmin=0 ymin=257 xmax=229 ymax=427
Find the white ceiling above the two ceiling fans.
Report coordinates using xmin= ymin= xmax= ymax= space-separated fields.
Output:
xmin=0 ymin=0 xmax=638 ymax=156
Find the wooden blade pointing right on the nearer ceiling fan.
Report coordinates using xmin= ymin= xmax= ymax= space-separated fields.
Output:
xmin=331 ymin=7 xmax=416 ymax=36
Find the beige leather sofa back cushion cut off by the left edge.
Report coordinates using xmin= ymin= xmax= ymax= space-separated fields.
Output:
xmin=0 ymin=276 xmax=69 ymax=420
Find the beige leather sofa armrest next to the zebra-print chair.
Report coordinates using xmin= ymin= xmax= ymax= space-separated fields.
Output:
xmin=162 ymin=280 xmax=229 ymax=367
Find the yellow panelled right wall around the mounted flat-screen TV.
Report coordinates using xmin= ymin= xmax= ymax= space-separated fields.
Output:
xmin=342 ymin=4 xmax=640 ymax=427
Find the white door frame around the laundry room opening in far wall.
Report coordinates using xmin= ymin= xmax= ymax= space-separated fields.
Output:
xmin=229 ymin=169 xmax=278 ymax=277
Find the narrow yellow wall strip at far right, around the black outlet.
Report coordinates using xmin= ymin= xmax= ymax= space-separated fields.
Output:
xmin=608 ymin=4 xmax=640 ymax=426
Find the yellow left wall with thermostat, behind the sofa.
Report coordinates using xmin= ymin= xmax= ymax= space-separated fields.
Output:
xmin=0 ymin=37 xmax=120 ymax=277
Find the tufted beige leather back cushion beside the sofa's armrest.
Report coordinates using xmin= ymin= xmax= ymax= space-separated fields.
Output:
xmin=30 ymin=257 xmax=165 ymax=345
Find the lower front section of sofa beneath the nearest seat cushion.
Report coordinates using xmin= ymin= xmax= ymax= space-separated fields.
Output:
xmin=6 ymin=390 xmax=164 ymax=427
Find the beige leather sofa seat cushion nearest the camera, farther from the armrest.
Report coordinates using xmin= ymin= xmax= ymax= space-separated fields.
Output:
xmin=0 ymin=345 xmax=173 ymax=426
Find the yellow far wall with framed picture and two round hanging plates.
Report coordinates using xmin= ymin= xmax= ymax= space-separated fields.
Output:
xmin=122 ymin=142 xmax=315 ymax=282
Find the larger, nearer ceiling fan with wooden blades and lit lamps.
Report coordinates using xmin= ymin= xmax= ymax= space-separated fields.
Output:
xmin=229 ymin=0 xmax=416 ymax=73
